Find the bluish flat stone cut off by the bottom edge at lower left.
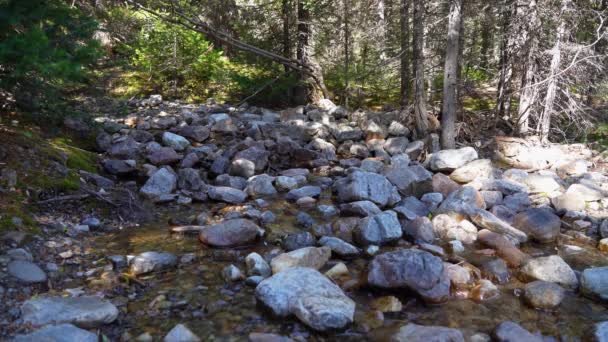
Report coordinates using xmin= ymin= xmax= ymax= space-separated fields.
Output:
xmin=13 ymin=324 xmax=98 ymax=342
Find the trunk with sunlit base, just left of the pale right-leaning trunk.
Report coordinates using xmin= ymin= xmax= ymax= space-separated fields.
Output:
xmin=517 ymin=0 xmax=539 ymax=135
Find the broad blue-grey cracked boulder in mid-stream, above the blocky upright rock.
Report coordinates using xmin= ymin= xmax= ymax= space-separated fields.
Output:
xmin=335 ymin=171 xmax=401 ymax=207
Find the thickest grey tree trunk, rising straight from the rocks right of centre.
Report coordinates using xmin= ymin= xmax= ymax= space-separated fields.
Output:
xmin=441 ymin=0 xmax=463 ymax=149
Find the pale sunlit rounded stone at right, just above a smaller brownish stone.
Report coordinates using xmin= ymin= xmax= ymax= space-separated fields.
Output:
xmin=521 ymin=255 xmax=578 ymax=289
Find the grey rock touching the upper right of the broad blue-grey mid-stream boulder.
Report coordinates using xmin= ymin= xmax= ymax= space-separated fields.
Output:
xmin=384 ymin=165 xmax=433 ymax=197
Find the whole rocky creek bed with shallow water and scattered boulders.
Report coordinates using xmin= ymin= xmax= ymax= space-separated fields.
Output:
xmin=0 ymin=96 xmax=608 ymax=341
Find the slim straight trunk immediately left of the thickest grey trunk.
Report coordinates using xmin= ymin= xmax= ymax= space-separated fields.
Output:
xmin=413 ymin=0 xmax=429 ymax=138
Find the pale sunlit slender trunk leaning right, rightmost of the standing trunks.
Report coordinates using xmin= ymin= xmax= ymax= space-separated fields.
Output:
xmin=538 ymin=0 xmax=569 ymax=142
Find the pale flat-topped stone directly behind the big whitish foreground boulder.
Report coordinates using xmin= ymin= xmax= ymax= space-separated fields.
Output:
xmin=270 ymin=247 xmax=331 ymax=274
